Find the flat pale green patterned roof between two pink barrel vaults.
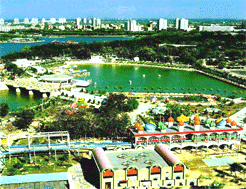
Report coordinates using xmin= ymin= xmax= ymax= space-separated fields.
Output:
xmin=106 ymin=149 xmax=169 ymax=169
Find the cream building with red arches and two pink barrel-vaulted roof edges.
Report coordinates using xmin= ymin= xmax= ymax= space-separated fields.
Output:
xmin=92 ymin=144 xmax=197 ymax=189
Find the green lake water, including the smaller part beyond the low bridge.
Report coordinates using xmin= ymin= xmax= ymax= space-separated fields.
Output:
xmin=0 ymin=64 xmax=246 ymax=110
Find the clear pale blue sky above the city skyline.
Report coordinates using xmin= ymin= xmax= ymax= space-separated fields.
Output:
xmin=0 ymin=0 xmax=246 ymax=19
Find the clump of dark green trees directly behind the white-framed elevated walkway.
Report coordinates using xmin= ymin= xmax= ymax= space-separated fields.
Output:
xmin=41 ymin=94 xmax=138 ymax=139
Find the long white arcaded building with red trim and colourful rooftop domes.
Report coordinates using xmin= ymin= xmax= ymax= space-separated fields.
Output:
xmin=130 ymin=114 xmax=244 ymax=150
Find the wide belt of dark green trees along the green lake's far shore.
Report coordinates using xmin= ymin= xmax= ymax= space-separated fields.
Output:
xmin=2 ymin=29 xmax=246 ymax=68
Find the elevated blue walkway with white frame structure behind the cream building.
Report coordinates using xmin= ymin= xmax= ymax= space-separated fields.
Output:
xmin=0 ymin=131 xmax=131 ymax=168
